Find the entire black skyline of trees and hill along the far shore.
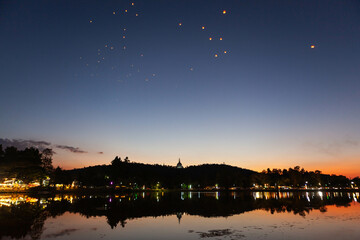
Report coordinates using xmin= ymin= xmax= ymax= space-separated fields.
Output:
xmin=0 ymin=145 xmax=360 ymax=189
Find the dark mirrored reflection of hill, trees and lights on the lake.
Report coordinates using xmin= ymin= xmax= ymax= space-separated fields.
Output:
xmin=0 ymin=192 xmax=359 ymax=239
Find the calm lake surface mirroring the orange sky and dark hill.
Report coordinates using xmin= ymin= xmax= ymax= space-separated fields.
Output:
xmin=0 ymin=192 xmax=360 ymax=240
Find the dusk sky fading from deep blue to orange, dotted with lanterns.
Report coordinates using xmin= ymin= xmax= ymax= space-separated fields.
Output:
xmin=0 ymin=0 xmax=360 ymax=177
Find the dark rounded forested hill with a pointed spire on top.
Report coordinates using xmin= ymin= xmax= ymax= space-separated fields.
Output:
xmin=55 ymin=159 xmax=256 ymax=188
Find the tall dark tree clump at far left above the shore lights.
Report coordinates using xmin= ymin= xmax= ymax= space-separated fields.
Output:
xmin=0 ymin=145 xmax=53 ymax=183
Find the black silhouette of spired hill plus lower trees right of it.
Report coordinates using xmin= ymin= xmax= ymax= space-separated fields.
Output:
xmin=50 ymin=156 xmax=360 ymax=189
